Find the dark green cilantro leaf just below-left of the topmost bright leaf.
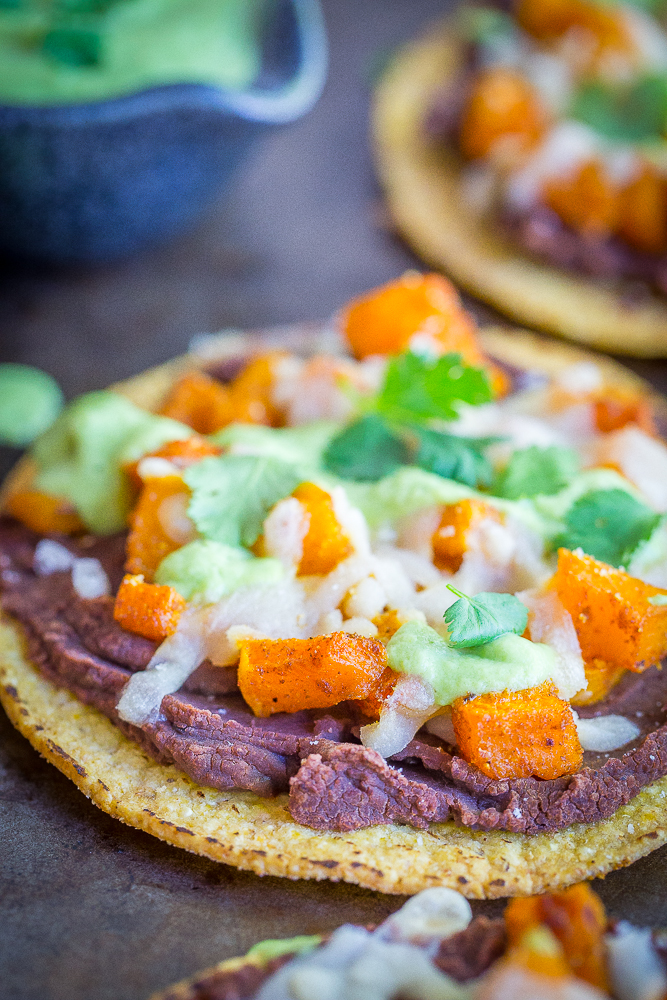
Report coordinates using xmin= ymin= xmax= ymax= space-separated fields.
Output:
xmin=323 ymin=413 xmax=410 ymax=482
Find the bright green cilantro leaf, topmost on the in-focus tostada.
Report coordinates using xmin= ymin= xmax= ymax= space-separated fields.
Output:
xmin=375 ymin=351 xmax=492 ymax=423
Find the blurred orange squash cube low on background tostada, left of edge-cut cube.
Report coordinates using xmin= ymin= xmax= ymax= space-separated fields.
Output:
xmin=543 ymin=160 xmax=619 ymax=236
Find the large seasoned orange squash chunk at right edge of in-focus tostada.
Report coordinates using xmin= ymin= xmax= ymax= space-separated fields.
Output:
xmin=550 ymin=549 xmax=667 ymax=673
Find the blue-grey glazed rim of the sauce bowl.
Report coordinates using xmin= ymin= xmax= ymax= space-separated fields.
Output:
xmin=0 ymin=0 xmax=328 ymax=126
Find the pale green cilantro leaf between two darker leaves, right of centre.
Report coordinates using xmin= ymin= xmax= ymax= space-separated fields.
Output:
xmin=492 ymin=445 xmax=579 ymax=500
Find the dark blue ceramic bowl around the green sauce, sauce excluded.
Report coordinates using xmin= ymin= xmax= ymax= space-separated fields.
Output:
xmin=0 ymin=0 xmax=327 ymax=263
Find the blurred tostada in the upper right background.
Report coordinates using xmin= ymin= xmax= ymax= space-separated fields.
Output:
xmin=373 ymin=0 xmax=667 ymax=357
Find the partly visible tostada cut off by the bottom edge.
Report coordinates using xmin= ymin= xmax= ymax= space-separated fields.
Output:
xmin=152 ymin=883 xmax=667 ymax=1000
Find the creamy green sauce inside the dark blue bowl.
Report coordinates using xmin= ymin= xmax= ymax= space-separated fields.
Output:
xmin=0 ymin=0 xmax=271 ymax=105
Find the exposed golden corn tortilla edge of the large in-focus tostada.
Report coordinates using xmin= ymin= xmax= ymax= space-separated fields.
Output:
xmin=0 ymin=328 xmax=667 ymax=899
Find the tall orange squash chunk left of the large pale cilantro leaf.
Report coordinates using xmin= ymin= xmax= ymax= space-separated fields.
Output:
xmin=125 ymin=476 xmax=189 ymax=581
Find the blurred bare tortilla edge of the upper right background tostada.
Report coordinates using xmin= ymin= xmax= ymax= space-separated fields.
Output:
xmin=372 ymin=24 xmax=667 ymax=358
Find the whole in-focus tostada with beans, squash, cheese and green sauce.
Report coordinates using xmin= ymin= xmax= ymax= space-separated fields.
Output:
xmin=0 ymin=272 xmax=667 ymax=897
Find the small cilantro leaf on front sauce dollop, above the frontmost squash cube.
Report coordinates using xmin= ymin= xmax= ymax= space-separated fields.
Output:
xmin=443 ymin=584 xmax=528 ymax=649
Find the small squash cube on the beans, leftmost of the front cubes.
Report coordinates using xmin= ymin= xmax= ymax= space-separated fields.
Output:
xmin=113 ymin=575 xmax=187 ymax=642
